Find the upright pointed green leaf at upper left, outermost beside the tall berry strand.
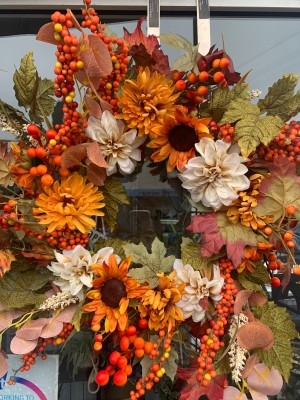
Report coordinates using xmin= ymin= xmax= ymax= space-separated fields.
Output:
xmin=13 ymin=51 xmax=38 ymax=110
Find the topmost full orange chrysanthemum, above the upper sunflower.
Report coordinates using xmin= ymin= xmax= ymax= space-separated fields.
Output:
xmin=116 ymin=67 xmax=180 ymax=136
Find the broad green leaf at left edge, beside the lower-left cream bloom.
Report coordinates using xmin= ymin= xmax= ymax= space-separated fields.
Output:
xmin=0 ymin=270 xmax=49 ymax=310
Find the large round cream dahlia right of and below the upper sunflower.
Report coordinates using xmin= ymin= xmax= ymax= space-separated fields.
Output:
xmin=179 ymin=138 xmax=250 ymax=209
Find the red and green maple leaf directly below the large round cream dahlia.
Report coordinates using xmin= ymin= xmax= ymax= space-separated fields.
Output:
xmin=187 ymin=212 xmax=257 ymax=267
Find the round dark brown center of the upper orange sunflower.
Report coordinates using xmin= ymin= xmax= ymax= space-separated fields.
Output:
xmin=169 ymin=124 xmax=199 ymax=151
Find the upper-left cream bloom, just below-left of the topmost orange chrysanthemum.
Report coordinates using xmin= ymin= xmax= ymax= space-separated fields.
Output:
xmin=86 ymin=110 xmax=146 ymax=175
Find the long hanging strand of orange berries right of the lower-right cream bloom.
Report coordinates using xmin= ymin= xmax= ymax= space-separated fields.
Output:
xmin=197 ymin=258 xmax=238 ymax=387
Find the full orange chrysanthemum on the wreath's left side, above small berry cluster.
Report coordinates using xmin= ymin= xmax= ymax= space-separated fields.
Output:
xmin=33 ymin=172 xmax=105 ymax=233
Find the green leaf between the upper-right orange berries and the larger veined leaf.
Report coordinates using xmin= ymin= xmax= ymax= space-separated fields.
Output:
xmin=201 ymin=83 xmax=249 ymax=122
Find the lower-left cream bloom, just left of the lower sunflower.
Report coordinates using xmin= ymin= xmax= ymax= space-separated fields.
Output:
xmin=48 ymin=245 xmax=114 ymax=299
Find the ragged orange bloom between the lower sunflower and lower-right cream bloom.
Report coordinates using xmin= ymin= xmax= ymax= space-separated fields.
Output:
xmin=138 ymin=271 xmax=185 ymax=330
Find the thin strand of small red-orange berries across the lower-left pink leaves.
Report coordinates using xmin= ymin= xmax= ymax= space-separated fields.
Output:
xmin=19 ymin=322 xmax=73 ymax=372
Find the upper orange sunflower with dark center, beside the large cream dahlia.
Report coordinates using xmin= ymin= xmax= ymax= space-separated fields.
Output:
xmin=147 ymin=108 xmax=212 ymax=172
